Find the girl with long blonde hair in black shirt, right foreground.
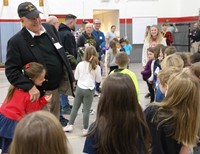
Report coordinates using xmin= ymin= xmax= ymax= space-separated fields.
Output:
xmin=145 ymin=71 xmax=200 ymax=154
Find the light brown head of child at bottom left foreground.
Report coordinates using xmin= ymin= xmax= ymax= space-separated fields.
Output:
xmin=10 ymin=111 xmax=69 ymax=154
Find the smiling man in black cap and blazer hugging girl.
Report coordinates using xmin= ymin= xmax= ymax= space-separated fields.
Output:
xmin=5 ymin=2 xmax=74 ymax=117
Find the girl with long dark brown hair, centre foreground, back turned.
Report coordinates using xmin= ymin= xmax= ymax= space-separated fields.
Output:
xmin=83 ymin=73 xmax=151 ymax=154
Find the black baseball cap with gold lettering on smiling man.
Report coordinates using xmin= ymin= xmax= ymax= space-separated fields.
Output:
xmin=17 ymin=2 xmax=42 ymax=19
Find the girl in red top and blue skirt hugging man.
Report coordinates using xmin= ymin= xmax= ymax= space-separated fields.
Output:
xmin=0 ymin=62 xmax=52 ymax=153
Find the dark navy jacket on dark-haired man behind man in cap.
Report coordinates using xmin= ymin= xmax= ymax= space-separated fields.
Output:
xmin=58 ymin=23 xmax=77 ymax=57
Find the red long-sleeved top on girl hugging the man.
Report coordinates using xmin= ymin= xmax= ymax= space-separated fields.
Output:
xmin=0 ymin=89 xmax=48 ymax=121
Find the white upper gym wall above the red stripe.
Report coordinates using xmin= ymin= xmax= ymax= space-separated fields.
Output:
xmin=0 ymin=0 xmax=200 ymax=19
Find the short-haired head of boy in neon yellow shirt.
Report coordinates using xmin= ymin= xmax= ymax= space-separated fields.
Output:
xmin=115 ymin=52 xmax=129 ymax=67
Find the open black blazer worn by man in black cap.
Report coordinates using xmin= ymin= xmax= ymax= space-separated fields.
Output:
xmin=5 ymin=23 xmax=74 ymax=95
